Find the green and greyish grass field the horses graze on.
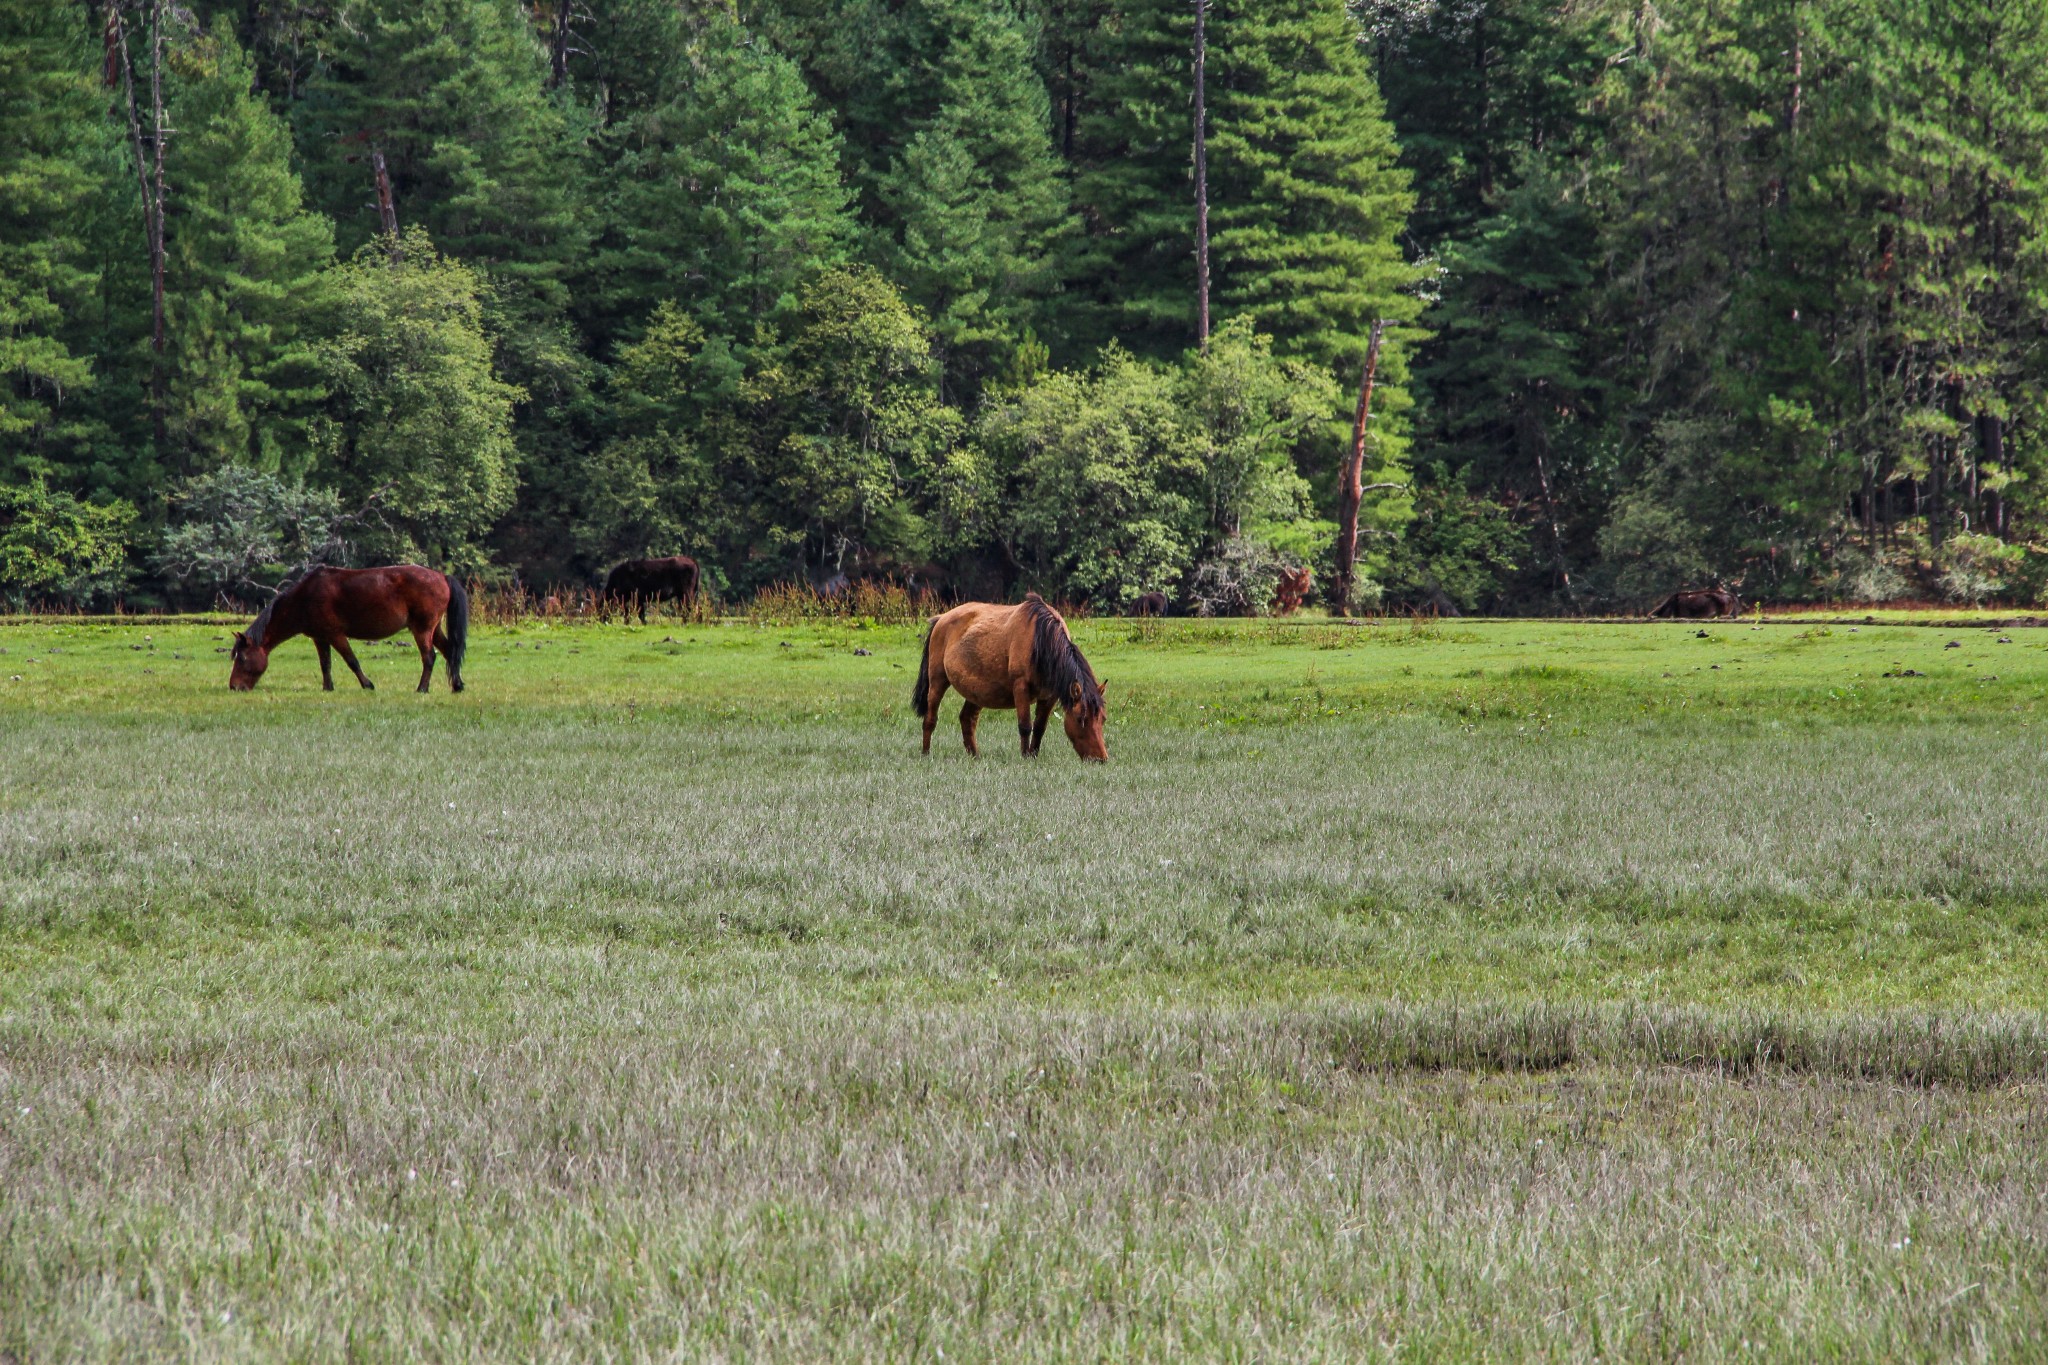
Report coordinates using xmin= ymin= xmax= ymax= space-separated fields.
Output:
xmin=0 ymin=620 xmax=2048 ymax=1361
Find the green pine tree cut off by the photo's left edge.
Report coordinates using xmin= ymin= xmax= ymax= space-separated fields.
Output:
xmin=0 ymin=0 xmax=119 ymax=483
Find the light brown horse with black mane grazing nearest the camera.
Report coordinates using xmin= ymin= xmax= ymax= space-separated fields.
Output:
xmin=909 ymin=593 xmax=1110 ymax=761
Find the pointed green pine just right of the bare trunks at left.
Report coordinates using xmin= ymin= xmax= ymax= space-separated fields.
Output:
xmin=166 ymin=18 xmax=334 ymax=475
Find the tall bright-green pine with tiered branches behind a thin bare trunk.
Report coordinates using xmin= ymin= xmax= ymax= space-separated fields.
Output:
xmin=1077 ymin=0 xmax=1419 ymax=370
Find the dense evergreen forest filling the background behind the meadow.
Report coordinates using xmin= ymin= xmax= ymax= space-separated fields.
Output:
xmin=0 ymin=0 xmax=2048 ymax=614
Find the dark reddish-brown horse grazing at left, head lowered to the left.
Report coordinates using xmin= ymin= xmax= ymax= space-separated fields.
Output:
xmin=227 ymin=565 xmax=469 ymax=692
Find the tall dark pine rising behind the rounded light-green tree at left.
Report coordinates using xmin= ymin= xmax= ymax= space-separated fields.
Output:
xmin=293 ymin=0 xmax=596 ymax=569
